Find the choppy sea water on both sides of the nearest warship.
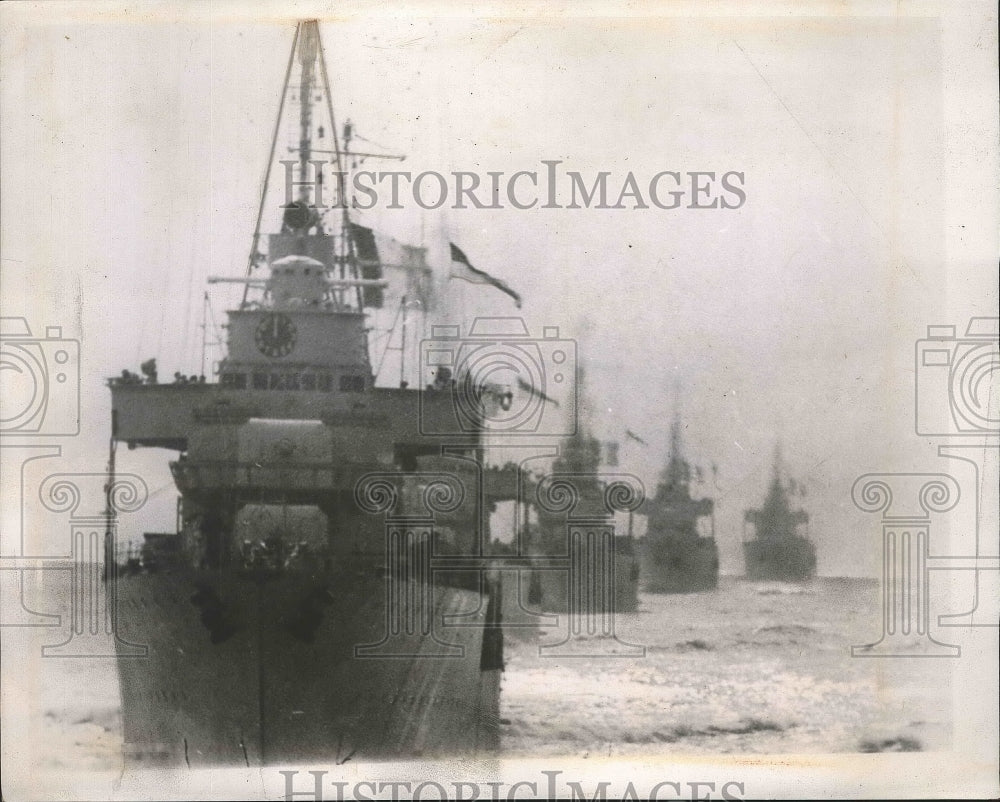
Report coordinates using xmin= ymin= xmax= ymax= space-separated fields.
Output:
xmin=0 ymin=571 xmax=954 ymax=776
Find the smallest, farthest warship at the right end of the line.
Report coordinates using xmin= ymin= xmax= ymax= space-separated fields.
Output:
xmin=743 ymin=449 xmax=816 ymax=582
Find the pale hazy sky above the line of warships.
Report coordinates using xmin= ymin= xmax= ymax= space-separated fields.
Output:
xmin=2 ymin=1 xmax=997 ymax=574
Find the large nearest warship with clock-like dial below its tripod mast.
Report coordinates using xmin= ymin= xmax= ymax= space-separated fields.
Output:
xmin=107 ymin=21 xmax=517 ymax=768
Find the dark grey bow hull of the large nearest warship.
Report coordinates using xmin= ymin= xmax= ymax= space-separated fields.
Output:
xmin=114 ymin=570 xmax=502 ymax=767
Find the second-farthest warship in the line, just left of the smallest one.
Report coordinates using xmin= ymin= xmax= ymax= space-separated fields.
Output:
xmin=642 ymin=417 xmax=719 ymax=593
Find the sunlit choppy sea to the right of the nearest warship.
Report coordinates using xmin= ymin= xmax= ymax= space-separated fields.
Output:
xmin=502 ymin=577 xmax=953 ymax=757
